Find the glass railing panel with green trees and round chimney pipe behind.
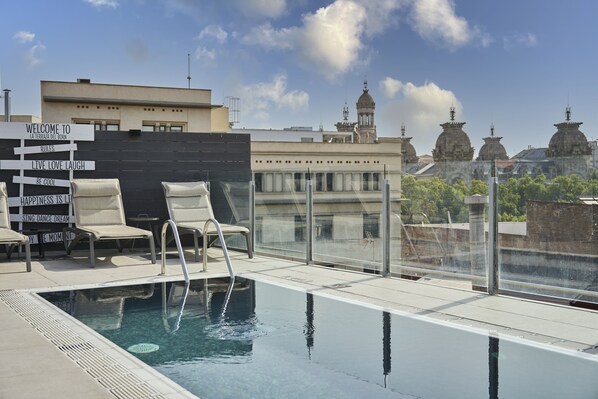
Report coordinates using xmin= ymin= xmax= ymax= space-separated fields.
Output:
xmin=391 ymin=162 xmax=489 ymax=289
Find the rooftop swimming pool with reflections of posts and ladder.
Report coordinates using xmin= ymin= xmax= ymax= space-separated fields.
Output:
xmin=42 ymin=278 xmax=598 ymax=399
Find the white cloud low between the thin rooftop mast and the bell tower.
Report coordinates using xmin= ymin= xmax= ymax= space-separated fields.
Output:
xmin=241 ymin=74 xmax=309 ymax=123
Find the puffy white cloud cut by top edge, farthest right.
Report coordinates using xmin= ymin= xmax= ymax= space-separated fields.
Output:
xmin=411 ymin=0 xmax=476 ymax=49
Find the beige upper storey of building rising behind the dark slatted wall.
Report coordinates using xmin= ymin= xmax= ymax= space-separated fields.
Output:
xmin=41 ymin=81 xmax=221 ymax=132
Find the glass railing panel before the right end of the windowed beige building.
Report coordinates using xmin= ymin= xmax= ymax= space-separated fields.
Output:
xmin=313 ymin=177 xmax=382 ymax=273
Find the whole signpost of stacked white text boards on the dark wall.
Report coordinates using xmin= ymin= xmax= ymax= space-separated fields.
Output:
xmin=0 ymin=122 xmax=95 ymax=244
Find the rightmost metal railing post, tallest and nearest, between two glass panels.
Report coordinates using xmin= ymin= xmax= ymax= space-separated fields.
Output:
xmin=487 ymin=161 xmax=499 ymax=295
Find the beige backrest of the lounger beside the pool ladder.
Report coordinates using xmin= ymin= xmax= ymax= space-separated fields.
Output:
xmin=162 ymin=181 xmax=214 ymax=223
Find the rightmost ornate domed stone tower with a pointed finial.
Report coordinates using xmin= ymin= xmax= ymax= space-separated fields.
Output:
xmin=546 ymin=107 xmax=592 ymax=176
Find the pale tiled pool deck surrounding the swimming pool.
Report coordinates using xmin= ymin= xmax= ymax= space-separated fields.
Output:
xmin=0 ymin=249 xmax=598 ymax=399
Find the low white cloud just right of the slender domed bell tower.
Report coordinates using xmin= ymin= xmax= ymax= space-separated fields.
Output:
xmin=378 ymin=78 xmax=463 ymax=154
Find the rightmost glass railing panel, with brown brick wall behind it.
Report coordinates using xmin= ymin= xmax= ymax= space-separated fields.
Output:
xmin=498 ymin=156 xmax=598 ymax=307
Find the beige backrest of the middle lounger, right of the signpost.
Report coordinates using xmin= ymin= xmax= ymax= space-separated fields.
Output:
xmin=71 ymin=179 xmax=126 ymax=226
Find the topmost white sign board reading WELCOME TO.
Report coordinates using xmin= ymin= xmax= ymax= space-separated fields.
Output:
xmin=0 ymin=122 xmax=94 ymax=141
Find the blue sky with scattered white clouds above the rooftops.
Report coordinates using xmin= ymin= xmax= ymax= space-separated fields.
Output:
xmin=0 ymin=0 xmax=598 ymax=156
